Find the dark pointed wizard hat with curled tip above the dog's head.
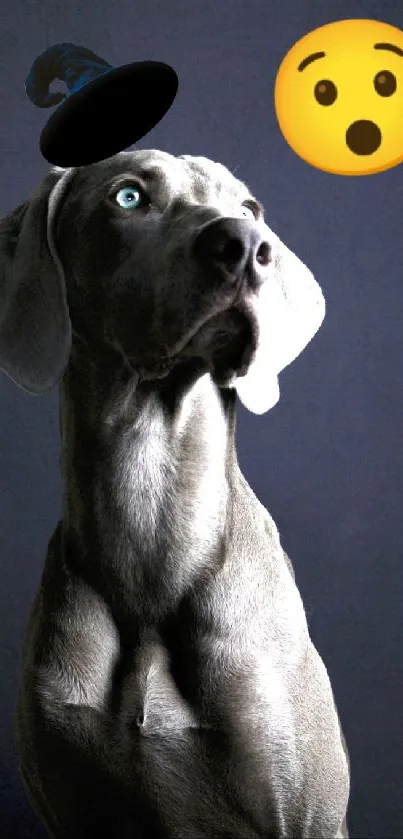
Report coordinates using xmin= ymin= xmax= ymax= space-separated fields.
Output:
xmin=25 ymin=44 xmax=178 ymax=167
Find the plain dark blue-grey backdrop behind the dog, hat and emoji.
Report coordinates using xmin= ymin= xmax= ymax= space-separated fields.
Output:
xmin=0 ymin=0 xmax=403 ymax=839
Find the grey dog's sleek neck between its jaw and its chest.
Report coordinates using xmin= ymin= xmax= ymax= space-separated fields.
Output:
xmin=61 ymin=348 xmax=236 ymax=622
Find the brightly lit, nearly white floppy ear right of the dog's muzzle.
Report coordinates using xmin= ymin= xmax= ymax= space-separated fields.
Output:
xmin=234 ymin=227 xmax=325 ymax=414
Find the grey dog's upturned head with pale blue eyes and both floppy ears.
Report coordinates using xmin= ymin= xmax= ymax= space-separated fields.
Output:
xmin=0 ymin=151 xmax=325 ymax=413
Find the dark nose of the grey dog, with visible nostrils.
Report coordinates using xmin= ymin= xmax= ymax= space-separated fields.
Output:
xmin=193 ymin=218 xmax=271 ymax=288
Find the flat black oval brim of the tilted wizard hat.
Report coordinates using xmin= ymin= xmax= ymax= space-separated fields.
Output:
xmin=40 ymin=61 xmax=178 ymax=168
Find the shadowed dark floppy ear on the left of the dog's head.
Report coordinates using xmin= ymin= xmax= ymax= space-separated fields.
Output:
xmin=0 ymin=169 xmax=72 ymax=394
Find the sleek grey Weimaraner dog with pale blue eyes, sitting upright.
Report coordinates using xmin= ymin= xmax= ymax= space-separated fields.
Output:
xmin=0 ymin=151 xmax=350 ymax=839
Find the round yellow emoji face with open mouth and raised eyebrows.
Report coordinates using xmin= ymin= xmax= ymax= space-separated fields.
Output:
xmin=274 ymin=20 xmax=403 ymax=175
